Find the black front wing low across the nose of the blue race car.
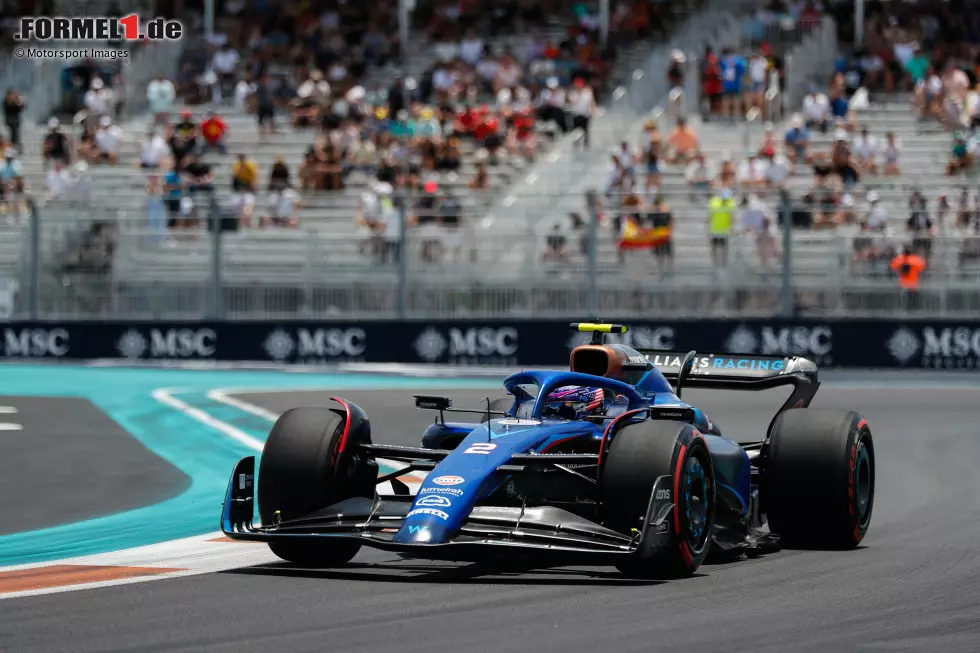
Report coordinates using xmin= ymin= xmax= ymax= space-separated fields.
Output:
xmin=221 ymin=456 xmax=674 ymax=561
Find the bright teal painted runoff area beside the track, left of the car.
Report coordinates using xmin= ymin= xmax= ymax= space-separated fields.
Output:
xmin=0 ymin=365 xmax=500 ymax=567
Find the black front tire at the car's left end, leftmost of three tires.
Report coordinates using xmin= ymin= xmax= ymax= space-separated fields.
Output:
xmin=258 ymin=404 xmax=378 ymax=567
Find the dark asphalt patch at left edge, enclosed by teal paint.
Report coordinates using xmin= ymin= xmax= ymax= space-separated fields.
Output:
xmin=0 ymin=397 xmax=190 ymax=536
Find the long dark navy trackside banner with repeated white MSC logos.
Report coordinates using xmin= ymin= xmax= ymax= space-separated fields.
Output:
xmin=0 ymin=320 xmax=980 ymax=370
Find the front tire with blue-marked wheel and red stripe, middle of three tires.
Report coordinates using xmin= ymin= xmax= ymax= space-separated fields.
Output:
xmin=599 ymin=420 xmax=715 ymax=578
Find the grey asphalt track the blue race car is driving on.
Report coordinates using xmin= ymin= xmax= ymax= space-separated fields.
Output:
xmin=0 ymin=384 xmax=980 ymax=653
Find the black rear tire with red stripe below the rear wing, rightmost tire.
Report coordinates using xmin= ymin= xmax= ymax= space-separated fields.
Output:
xmin=762 ymin=408 xmax=875 ymax=549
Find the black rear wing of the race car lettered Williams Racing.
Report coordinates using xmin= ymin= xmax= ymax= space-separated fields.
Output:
xmin=639 ymin=350 xmax=820 ymax=426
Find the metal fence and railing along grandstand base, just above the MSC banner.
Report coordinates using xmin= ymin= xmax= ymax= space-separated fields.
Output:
xmin=0 ymin=202 xmax=980 ymax=319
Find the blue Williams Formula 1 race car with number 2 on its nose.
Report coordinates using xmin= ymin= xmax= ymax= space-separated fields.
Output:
xmin=221 ymin=324 xmax=875 ymax=577
